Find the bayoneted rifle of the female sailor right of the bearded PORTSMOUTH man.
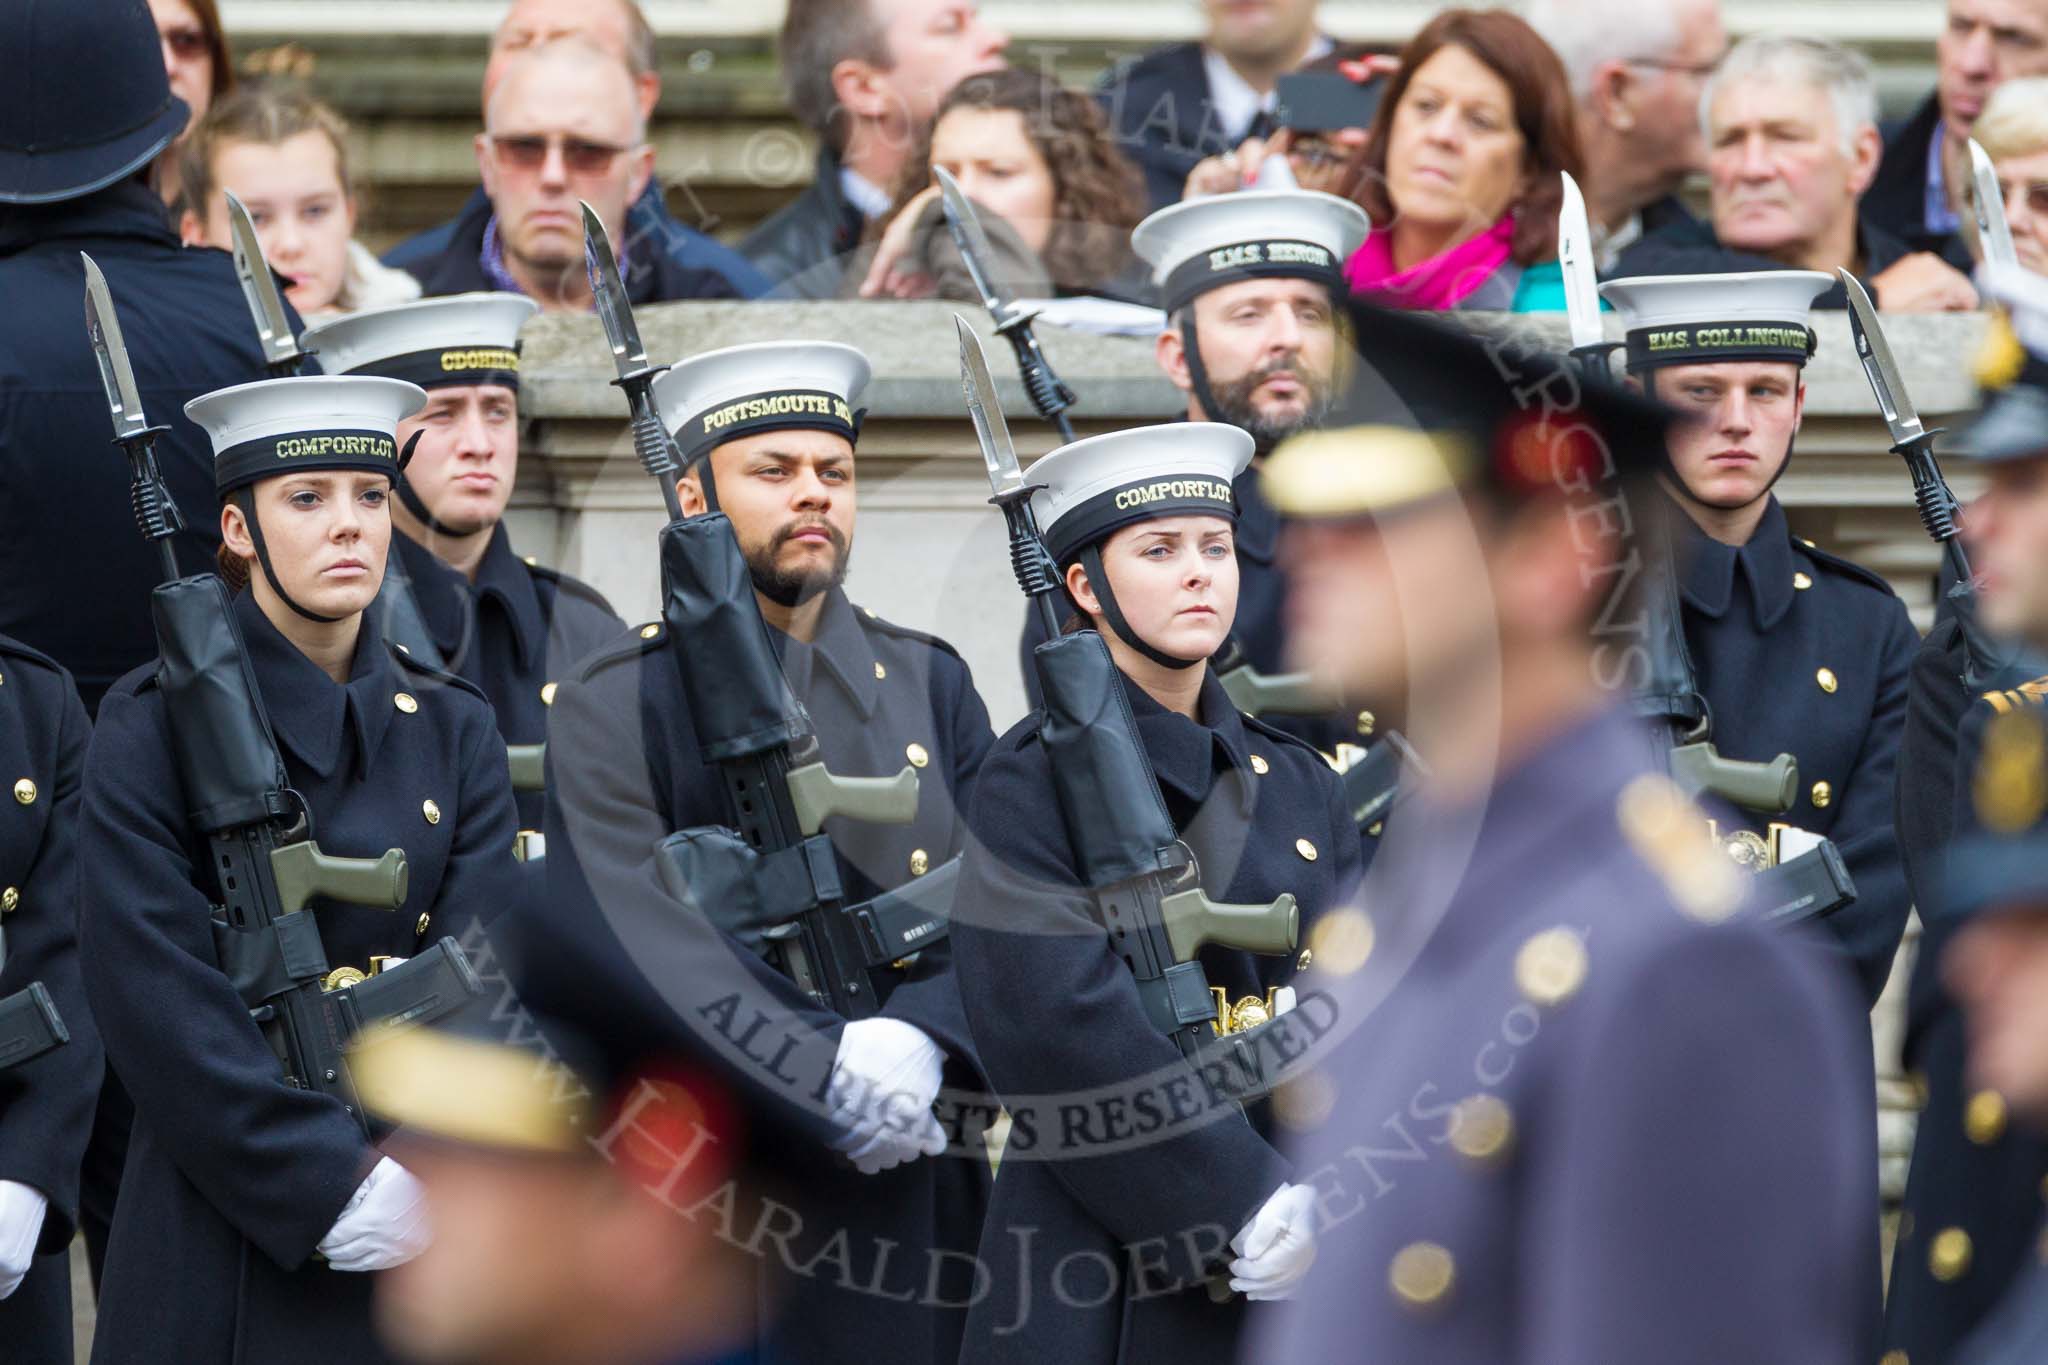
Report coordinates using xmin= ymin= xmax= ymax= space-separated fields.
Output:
xmin=954 ymin=315 xmax=1300 ymax=1099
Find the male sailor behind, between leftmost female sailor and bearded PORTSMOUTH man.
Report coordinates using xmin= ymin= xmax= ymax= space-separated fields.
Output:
xmin=301 ymin=295 xmax=625 ymax=849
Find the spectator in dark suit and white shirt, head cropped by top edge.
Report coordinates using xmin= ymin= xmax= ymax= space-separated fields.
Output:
xmin=1100 ymin=0 xmax=1331 ymax=209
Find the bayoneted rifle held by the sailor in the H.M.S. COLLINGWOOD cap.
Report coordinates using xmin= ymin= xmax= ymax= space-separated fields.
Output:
xmin=1559 ymin=172 xmax=1855 ymax=923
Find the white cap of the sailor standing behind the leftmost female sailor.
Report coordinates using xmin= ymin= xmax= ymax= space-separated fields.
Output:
xmin=299 ymin=293 xmax=541 ymax=389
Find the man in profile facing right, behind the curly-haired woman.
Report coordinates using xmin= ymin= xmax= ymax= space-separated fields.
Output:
xmin=739 ymin=0 xmax=1010 ymax=299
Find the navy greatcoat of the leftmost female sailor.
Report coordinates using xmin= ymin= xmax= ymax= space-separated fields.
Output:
xmin=80 ymin=591 xmax=516 ymax=1365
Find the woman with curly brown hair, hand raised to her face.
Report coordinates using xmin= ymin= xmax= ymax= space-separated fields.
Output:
xmin=848 ymin=68 xmax=1145 ymax=299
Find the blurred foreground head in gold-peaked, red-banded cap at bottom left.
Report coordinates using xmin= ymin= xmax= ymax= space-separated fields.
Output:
xmin=352 ymin=1002 xmax=754 ymax=1365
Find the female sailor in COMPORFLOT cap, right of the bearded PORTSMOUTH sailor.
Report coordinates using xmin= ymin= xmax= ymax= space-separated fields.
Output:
xmin=954 ymin=424 xmax=1362 ymax=1363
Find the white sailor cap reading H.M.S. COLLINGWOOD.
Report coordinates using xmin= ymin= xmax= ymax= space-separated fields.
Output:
xmin=1599 ymin=270 xmax=1835 ymax=375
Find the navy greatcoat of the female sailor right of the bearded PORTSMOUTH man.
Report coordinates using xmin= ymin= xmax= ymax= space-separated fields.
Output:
xmin=952 ymin=675 xmax=1364 ymax=1365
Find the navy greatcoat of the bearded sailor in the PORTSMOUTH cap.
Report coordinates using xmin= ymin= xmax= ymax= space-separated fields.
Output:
xmin=540 ymin=589 xmax=993 ymax=1365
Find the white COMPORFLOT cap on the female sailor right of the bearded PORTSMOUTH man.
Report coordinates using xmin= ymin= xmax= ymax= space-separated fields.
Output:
xmin=1024 ymin=422 xmax=1255 ymax=565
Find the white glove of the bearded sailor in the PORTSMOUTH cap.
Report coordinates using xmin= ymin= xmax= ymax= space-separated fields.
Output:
xmin=831 ymin=1017 xmax=946 ymax=1175
